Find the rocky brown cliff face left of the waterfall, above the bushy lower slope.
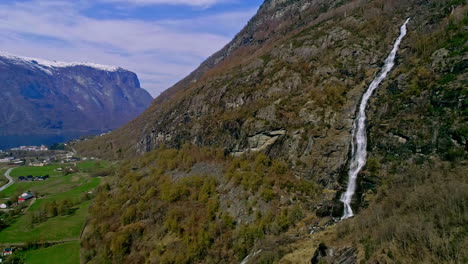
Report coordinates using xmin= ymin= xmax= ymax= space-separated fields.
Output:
xmin=75 ymin=0 xmax=422 ymax=188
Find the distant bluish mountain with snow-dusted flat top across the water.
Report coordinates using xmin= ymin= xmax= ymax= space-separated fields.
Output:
xmin=0 ymin=53 xmax=152 ymax=150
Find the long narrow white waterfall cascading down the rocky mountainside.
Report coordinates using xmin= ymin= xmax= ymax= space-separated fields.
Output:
xmin=341 ymin=18 xmax=410 ymax=219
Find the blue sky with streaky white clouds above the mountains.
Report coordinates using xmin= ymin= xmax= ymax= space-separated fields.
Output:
xmin=0 ymin=0 xmax=263 ymax=97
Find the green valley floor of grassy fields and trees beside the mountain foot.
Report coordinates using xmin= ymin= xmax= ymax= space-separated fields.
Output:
xmin=0 ymin=161 xmax=109 ymax=263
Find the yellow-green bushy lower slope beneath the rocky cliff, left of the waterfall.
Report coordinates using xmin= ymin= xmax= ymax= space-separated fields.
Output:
xmin=82 ymin=145 xmax=321 ymax=263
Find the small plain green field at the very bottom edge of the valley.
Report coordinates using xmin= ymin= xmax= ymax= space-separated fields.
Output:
xmin=24 ymin=241 xmax=80 ymax=264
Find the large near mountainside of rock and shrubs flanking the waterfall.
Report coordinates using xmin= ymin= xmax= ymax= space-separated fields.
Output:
xmin=77 ymin=0 xmax=468 ymax=263
